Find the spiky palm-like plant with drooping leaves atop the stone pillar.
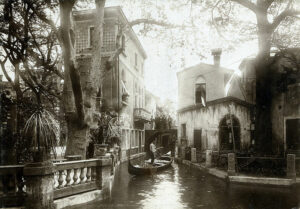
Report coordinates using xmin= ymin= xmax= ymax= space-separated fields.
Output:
xmin=24 ymin=108 xmax=59 ymax=159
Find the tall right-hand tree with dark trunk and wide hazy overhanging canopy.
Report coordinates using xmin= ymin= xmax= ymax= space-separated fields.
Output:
xmin=122 ymin=0 xmax=300 ymax=153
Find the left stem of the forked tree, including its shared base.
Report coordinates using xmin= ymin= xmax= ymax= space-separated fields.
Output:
xmin=60 ymin=0 xmax=87 ymax=159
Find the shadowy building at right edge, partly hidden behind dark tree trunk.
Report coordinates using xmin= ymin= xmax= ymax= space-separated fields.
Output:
xmin=240 ymin=49 xmax=300 ymax=156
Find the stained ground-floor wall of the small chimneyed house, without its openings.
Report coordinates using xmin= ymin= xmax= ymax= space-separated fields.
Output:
xmin=178 ymin=101 xmax=250 ymax=150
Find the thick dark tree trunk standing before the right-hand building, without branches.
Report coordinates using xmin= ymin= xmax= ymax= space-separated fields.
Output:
xmin=255 ymin=16 xmax=272 ymax=154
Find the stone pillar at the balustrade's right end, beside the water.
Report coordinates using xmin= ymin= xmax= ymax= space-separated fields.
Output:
xmin=96 ymin=156 xmax=112 ymax=199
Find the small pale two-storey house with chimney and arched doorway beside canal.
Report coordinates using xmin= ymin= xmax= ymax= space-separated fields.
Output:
xmin=177 ymin=50 xmax=251 ymax=157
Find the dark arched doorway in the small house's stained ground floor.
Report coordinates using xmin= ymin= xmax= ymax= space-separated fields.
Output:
xmin=219 ymin=114 xmax=241 ymax=151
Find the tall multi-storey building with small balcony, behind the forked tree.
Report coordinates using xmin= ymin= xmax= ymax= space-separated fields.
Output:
xmin=73 ymin=7 xmax=151 ymax=160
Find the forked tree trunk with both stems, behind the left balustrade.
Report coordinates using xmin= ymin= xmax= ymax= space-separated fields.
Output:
xmin=60 ymin=0 xmax=105 ymax=159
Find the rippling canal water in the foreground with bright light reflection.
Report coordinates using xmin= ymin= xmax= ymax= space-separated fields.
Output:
xmin=72 ymin=163 xmax=300 ymax=209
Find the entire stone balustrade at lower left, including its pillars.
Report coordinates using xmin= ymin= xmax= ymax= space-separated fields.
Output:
xmin=0 ymin=156 xmax=112 ymax=208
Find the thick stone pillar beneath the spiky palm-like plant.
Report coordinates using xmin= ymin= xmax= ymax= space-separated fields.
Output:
xmin=24 ymin=161 xmax=54 ymax=209
